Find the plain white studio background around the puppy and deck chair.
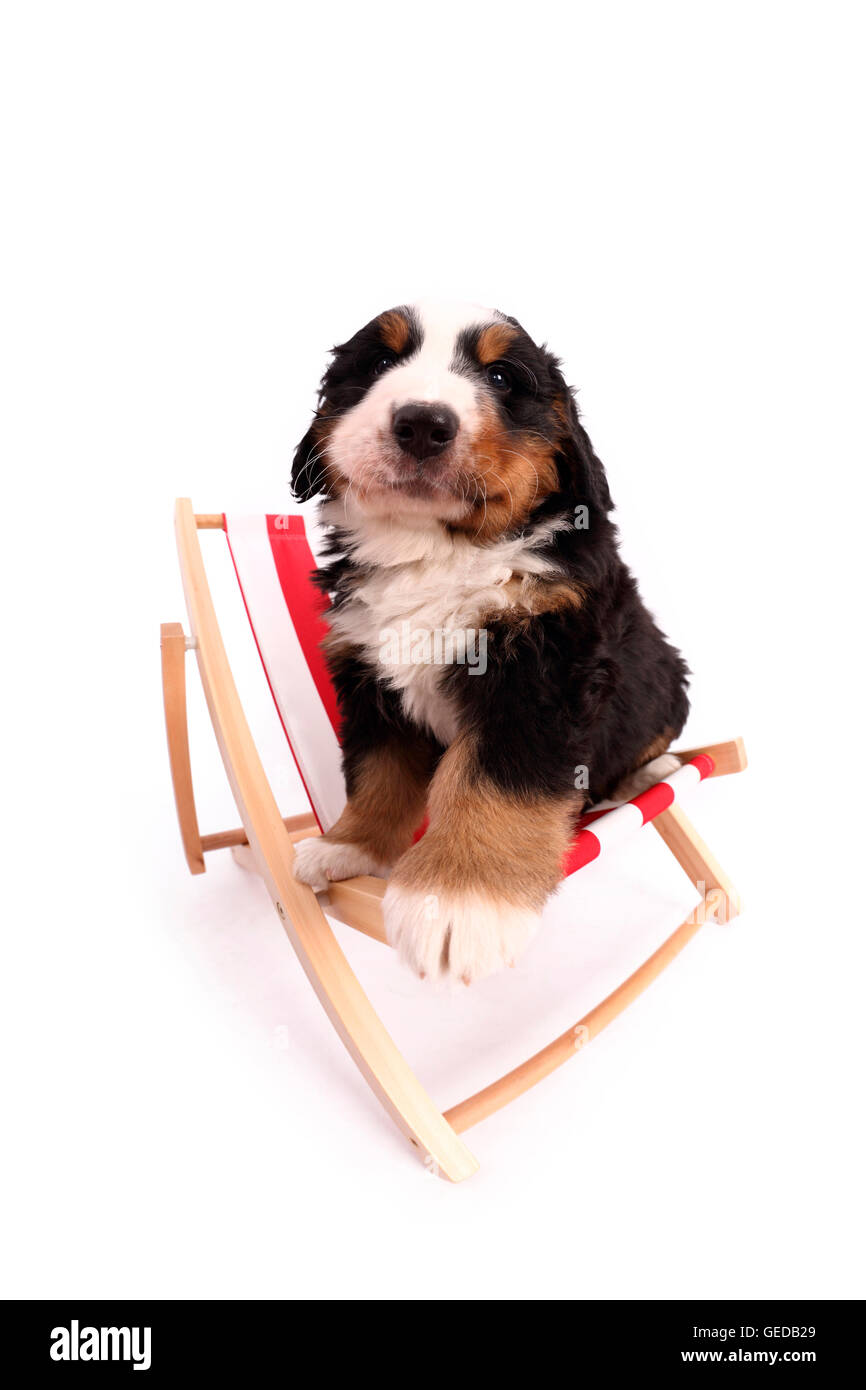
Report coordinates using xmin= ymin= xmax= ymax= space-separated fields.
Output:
xmin=0 ymin=0 xmax=866 ymax=1298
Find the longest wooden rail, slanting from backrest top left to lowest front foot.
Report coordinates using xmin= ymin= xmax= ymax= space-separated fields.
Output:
xmin=175 ymin=500 xmax=478 ymax=1182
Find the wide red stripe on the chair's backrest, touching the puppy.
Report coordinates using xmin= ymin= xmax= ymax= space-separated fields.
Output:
xmin=267 ymin=516 xmax=339 ymax=738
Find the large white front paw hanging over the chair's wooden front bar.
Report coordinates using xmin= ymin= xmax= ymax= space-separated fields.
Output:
xmin=382 ymin=883 xmax=541 ymax=984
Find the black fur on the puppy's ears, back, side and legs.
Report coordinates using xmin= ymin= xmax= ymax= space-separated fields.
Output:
xmin=292 ymin=298 xmax=688 ymax=801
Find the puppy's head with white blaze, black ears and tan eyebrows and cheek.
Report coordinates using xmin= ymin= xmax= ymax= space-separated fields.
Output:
xmin=292 ymin=304 xmax=612 ymax=539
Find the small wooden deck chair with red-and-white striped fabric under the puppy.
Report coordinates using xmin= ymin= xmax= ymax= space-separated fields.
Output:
xmin=161 ymin=499 xmax=746 ymax=1182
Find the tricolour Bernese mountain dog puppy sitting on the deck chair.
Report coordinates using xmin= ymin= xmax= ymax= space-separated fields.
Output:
xmin=292 ymin=303 xmax=688 ymax=984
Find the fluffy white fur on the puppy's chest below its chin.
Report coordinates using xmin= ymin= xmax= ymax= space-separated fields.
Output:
xmin=324 ymin=506 xmax=562 ymax=745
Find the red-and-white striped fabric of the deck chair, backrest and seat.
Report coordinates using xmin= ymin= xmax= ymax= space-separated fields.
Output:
xmin=225 ymin=514 xmax=713 ymax=874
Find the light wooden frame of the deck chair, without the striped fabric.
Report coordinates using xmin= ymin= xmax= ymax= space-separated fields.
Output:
xmin=161 ymin=499 xmax=746 ymax=1183
